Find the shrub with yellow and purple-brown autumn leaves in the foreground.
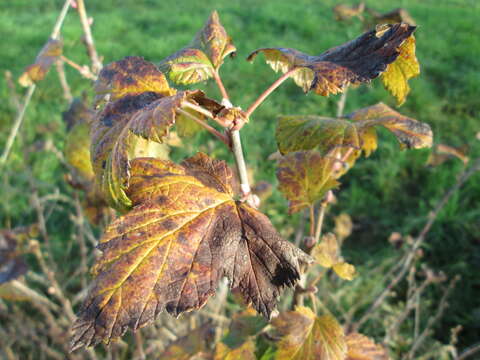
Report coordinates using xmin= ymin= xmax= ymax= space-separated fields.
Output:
xmin=17 ymin=7 xmax=432 ymax=359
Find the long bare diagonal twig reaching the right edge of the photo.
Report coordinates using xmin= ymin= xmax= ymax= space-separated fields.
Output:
xmin=353 ymin=158 xmax=480 ymax=331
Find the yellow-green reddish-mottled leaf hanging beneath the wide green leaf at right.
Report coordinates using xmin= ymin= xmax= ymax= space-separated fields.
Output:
xmin=277 ymin=151 xmax=340 ymax=213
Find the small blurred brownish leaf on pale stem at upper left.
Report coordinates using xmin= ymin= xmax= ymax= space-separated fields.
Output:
xmin=18 ymin=39 xmax=63 ymax=87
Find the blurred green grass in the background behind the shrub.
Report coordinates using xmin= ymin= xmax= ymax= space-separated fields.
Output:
xmin=0 ymin=0 xmax=480 ymax=345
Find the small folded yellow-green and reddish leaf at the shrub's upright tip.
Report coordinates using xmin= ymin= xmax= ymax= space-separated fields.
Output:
xmin=160 ymin=11 xmax=236 ymax=85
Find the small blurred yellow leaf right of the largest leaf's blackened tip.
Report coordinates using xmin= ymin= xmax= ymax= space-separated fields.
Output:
xmin=312 ymin=233 xmax=356 ymax=280
